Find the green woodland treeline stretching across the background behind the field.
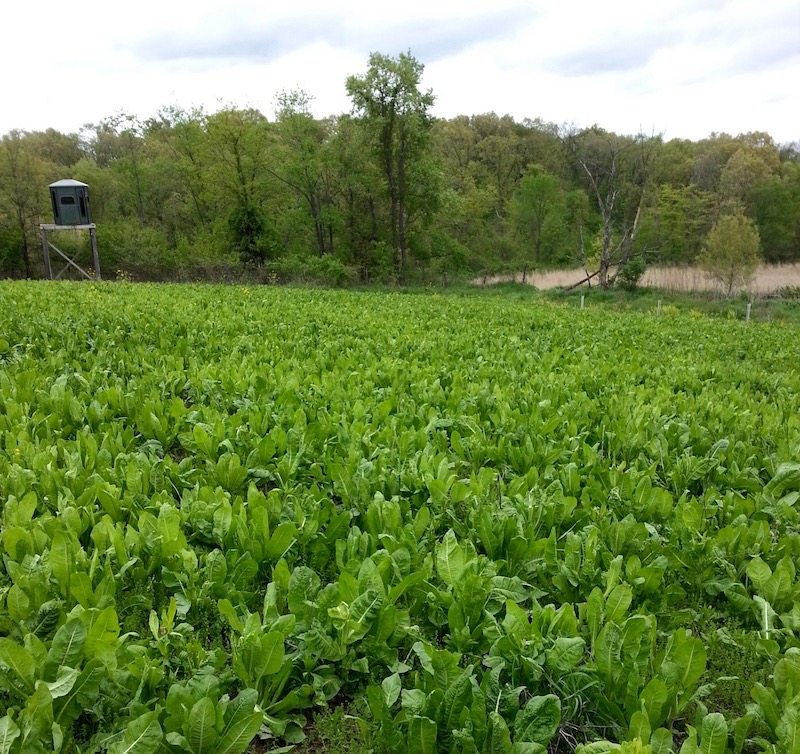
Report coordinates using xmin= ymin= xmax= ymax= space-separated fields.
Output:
xmin=0 ymin=53 xmax=800 ymax=284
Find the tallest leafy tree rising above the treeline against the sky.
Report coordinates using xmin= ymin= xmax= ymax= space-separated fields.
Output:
xmin=346 ymin=52 xmax=434 ymax=278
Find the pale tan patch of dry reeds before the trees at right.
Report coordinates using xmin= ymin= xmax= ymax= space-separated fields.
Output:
xmin=473 ymin=264 xmax=800 ymax=295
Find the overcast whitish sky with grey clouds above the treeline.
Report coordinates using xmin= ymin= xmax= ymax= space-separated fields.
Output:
xmin=0 ymin=0 xmax=800 ymax=142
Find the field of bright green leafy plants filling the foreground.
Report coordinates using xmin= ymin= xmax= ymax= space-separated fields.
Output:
xmin=0 ymin=282 xmax=800 ymax=754
